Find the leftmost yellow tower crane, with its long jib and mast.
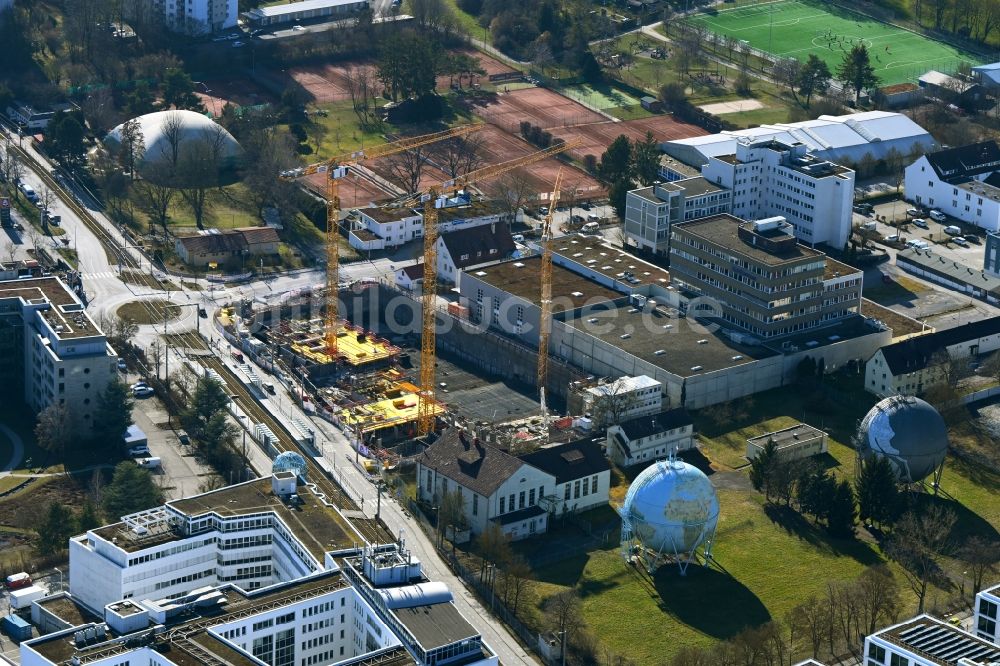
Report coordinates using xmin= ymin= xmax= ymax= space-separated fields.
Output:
xmin=279 ymin=124 xmax=483 ymax=360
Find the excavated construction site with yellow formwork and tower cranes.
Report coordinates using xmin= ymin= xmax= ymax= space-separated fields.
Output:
xmin=211 ymin=125 xmax=588 ymax=467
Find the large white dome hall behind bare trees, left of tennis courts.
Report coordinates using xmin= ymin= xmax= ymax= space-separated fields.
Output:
xmin=104 ymin=110 xmax=243 ymax=179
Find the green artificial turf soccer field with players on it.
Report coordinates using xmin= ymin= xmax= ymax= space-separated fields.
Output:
xmin=688 ymin=0 xmax=981 ymax=86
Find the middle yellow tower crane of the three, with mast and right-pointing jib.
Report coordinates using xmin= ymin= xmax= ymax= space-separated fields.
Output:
xmin=402 ymin=141 xmax=582 ymax=435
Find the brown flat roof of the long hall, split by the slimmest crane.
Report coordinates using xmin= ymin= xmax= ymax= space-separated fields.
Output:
xmin=467 ymin=255 xmax=622 ymax=312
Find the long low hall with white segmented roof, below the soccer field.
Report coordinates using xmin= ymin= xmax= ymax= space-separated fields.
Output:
xmin=660 ymin=111 xmax=935 ymax=169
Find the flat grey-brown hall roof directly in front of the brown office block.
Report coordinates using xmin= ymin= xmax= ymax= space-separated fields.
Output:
xmin=565 ymin=306 xmax=778 ymax=377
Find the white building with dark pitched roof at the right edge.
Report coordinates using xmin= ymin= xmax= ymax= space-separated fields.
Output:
xmin=905 ymin=140 xmax=1000 ymax=231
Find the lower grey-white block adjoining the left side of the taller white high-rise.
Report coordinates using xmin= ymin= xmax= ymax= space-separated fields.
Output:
xmin=625 ymin=176 xmax=732 ymax=257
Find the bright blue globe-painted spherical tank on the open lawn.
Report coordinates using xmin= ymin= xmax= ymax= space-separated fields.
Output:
xmin=621 ymin=460 xmax=719 ymax=573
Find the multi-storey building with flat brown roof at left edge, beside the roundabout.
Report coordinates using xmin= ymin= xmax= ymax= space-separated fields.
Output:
xmin=0 ymin=277 xmax=118 ymax=436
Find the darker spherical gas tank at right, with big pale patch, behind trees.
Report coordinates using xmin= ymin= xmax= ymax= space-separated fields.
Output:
xmin=857 ymin=396 xmax=948 ymax=484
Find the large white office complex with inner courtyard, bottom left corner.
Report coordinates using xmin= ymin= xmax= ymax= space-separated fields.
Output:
xmin=45 ymin=471 xmax=498 ymax=666
